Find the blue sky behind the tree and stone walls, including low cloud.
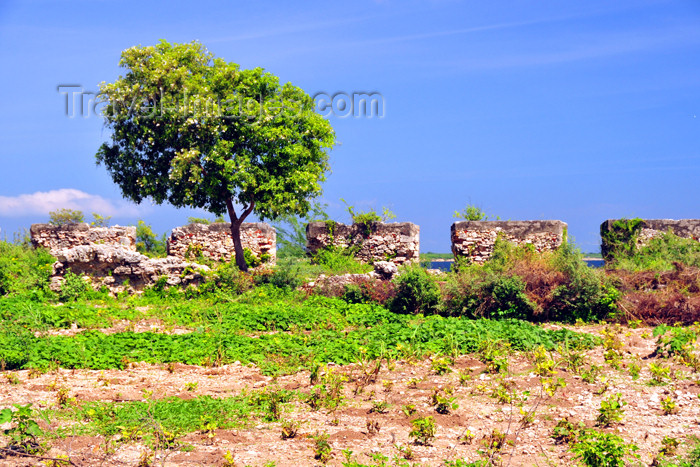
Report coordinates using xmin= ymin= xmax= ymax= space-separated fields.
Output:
xmin=0 ymin=0 xmax=700 ymax=252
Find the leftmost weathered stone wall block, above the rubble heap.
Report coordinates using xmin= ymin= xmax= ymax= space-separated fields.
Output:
xmin=29 ymin=223 xmax=136 ymax=254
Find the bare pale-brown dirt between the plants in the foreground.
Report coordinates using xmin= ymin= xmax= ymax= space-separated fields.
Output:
xmin=0 ymin=323 xmax=700 ymax=466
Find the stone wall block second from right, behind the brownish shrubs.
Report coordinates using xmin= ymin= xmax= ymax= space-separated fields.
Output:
xmin=451 ymin=221 xmax=567 ymax=263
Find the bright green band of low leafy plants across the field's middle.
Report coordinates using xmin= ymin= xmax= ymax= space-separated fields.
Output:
xmin=0 ymin=287 xmax=599 ymax=374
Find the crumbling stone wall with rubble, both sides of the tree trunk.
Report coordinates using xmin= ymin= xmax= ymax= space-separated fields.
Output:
xmin=30 ymin=223 xmax=276 ymax=293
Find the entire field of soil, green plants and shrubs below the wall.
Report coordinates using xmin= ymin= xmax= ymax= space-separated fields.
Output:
xmin=0 ymin=229 xmax=700 ymax=466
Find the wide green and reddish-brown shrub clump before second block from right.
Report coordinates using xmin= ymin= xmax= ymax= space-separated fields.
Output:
xmin=440 ymin=238 xmax=619 ymax=322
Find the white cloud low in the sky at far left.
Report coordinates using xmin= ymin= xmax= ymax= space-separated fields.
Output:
xmin=0 ymin=188 xmax=143 ymax=217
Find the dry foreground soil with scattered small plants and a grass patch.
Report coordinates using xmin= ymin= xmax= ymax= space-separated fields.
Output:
xmin=0 ymin=325 xmax=700 ymax=466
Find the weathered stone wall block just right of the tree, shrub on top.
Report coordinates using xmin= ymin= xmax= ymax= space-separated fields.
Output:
xmin=306 ymin=221 xmax=420 ymax=264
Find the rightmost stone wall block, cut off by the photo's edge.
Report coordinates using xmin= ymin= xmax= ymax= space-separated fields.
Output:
xmin=600 ymin=219 xmax=700 ymax=258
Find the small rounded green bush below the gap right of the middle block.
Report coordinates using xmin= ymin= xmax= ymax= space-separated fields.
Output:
xmin=389 ymin=265 xmax=440 ymax=314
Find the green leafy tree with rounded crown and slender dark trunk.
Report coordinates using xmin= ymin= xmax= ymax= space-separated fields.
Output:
xmin=97 ymin=41 xmax=335 ymax=271
